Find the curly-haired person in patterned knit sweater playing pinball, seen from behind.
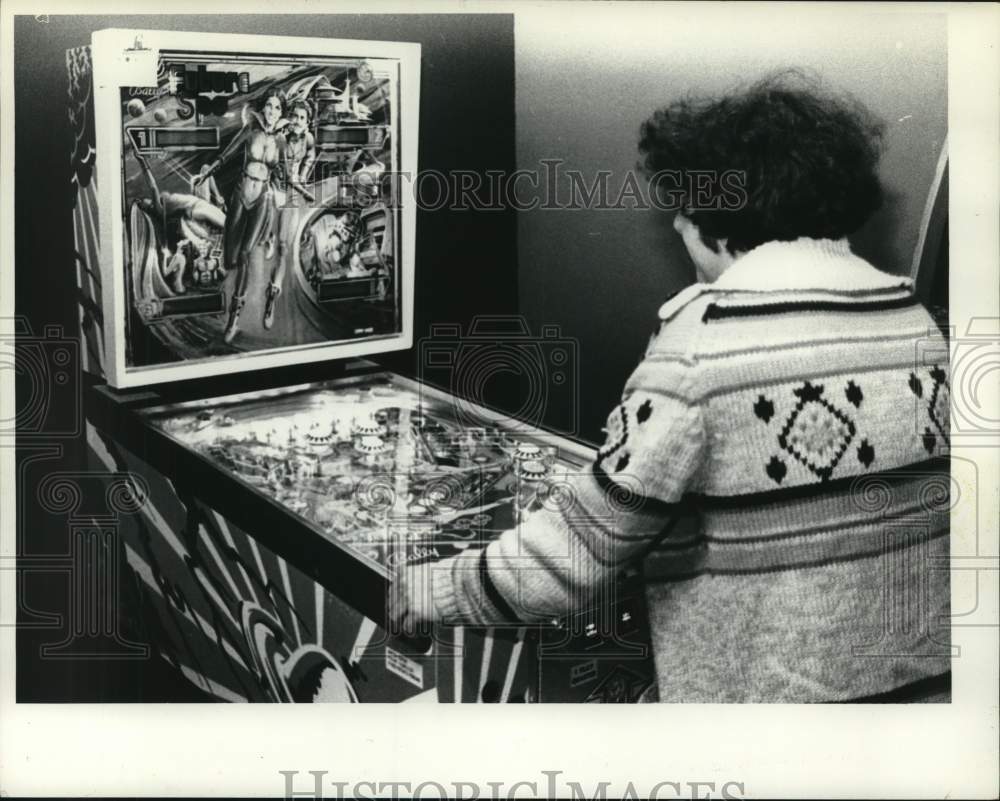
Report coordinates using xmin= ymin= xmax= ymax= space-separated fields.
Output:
xmin=390 ymin=75 xmax=950 ymax=702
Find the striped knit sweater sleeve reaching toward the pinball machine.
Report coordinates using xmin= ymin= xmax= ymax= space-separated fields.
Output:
xmin=430 ymin=358 xmax=706 ymax=625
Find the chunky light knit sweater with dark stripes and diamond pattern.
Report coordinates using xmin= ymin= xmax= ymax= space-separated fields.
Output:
xmin=430 ymin=239 xmax=950 ymax=702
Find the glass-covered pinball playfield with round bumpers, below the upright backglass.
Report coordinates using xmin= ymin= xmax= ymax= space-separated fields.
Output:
xmin=142 ymin=373 xmax=592 ymax=570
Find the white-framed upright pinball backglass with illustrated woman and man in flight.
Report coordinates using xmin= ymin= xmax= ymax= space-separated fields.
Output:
xmin=95 ymin=31 xmax=419 ymax=386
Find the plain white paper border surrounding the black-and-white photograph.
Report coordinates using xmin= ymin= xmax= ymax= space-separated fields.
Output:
xmin=0 ymin=0 xmax=1000 ymax=798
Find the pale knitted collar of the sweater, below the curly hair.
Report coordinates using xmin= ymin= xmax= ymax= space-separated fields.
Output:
xmin=659 ymin=237 xmax=913 ymax=320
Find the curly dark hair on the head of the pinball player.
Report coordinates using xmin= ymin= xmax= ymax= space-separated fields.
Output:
xmin=639 ymin=71 xmax=884 ymax=253
